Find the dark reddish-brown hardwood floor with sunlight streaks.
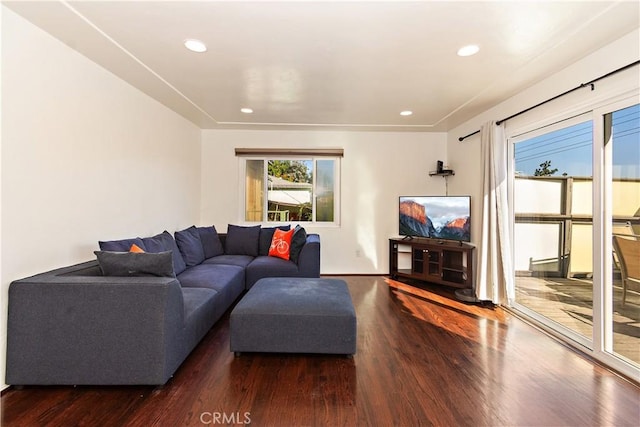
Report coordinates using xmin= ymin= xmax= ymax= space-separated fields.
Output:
xmin=2 ymin=276 xmax=640 ymax=426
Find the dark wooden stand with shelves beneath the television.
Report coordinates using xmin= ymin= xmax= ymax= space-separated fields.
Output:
xmin=389 ymin=238 xmax=475 ymax=288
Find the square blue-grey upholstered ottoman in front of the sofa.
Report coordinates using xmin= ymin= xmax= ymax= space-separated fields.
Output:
xmin=230 ymin=277 xmax=356 ymax=355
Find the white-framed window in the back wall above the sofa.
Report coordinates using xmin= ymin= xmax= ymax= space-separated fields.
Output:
xmin=236 ymin=150 xmax=340 ymax=224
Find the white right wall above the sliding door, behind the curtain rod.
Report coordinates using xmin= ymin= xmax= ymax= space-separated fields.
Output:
xmin=447 ymin=30 xmax=640 ymax=249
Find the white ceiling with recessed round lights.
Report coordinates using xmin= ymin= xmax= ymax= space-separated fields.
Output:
xmin=3 ymin=1 xmax=640 ymax=131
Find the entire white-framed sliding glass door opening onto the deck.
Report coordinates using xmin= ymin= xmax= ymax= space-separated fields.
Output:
xmin=510 ymin=98 xmax=640 ymax=376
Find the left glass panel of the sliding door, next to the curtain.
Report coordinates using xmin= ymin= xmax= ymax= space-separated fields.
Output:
xmin=513 ymin=116 xmax=593 ymax=346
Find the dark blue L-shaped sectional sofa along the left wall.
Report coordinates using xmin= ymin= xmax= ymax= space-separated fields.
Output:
xmin=6 ymin=225 xmax=320 ymax=385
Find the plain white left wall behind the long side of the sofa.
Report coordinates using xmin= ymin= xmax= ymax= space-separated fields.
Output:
xmin=0 ymin=7 xmax=201 ymax=392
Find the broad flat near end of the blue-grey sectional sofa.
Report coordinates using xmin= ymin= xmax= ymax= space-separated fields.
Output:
xmin=6 ymin=263 xmax=184 ymax=385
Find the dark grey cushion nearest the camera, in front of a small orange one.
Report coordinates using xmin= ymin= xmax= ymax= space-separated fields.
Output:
xmin=94 ymin=251 xmax=176 ymax=277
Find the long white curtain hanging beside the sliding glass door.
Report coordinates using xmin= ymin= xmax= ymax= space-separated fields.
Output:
xmin=475 ymin=122 xmax=514 ymax=304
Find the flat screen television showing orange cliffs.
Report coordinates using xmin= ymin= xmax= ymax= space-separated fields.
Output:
xmin=399 ymin=196 xmax=471 ymax=242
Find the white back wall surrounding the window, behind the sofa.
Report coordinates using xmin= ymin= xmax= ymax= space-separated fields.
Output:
xmin=201 ymin=130 xmax=448 ymax=274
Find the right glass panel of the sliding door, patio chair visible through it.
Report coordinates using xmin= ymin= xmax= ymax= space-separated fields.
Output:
xmin=602 ymin=104 xmax=640 ymax=365
